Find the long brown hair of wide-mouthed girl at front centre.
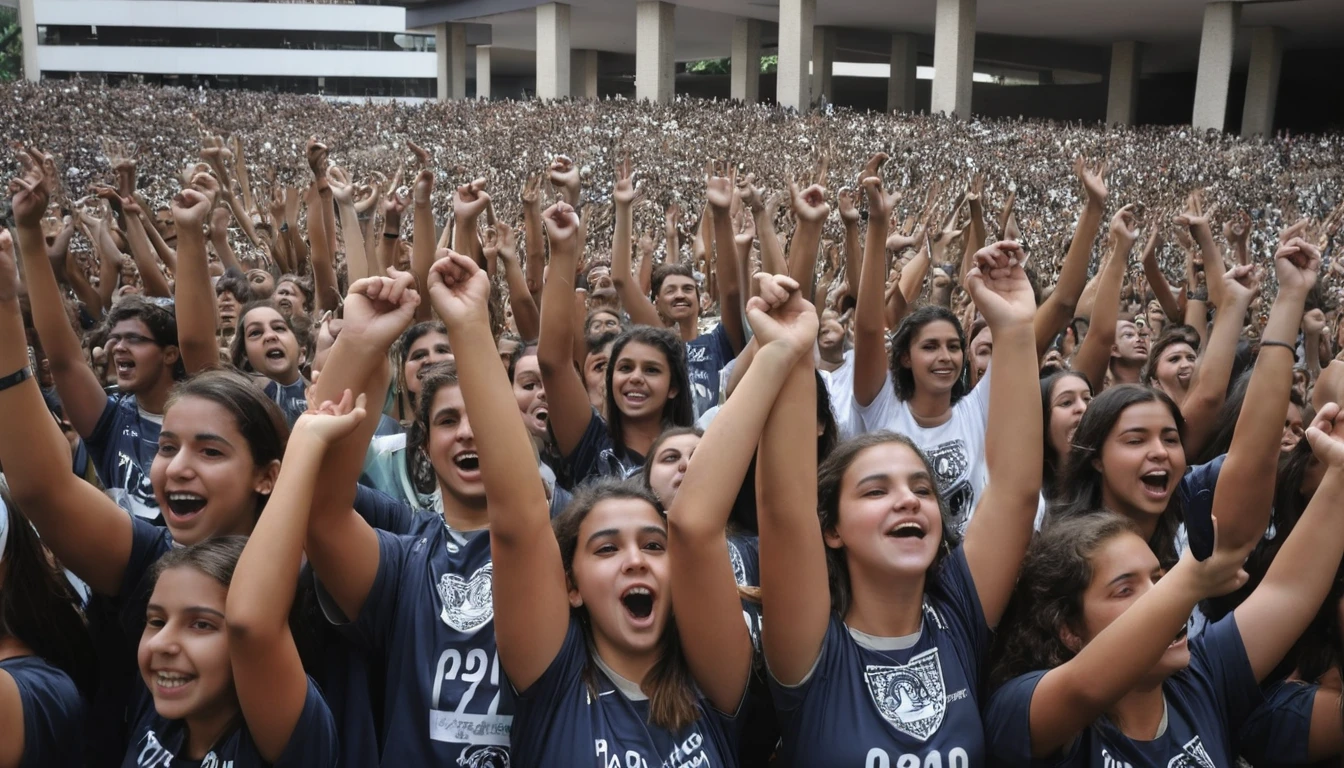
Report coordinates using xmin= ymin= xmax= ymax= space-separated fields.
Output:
xmin=551 ymin=479 xmax=700 ymax=732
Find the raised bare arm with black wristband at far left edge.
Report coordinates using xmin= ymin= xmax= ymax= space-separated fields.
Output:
xmin=0 ymin=225 xmax=130 ymax=596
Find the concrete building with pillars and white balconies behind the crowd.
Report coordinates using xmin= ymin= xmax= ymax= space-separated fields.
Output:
xmin=10 ymin=0 xmax=1344 ymax=136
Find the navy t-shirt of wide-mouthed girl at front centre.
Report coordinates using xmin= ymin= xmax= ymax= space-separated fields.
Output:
xmin=512 ymin=617 xmax=737 ymax=768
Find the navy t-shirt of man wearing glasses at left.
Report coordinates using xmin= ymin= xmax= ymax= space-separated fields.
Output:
xmin=83 ymin=394 xmax=163 ymax=525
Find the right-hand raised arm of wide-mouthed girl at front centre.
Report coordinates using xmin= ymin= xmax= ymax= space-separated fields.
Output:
xmin=668 ymin=276 xmax=817 ymax=712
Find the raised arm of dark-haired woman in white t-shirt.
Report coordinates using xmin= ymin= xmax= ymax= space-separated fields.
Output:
xmin=853 ymin=176 xmax=898 ymax=406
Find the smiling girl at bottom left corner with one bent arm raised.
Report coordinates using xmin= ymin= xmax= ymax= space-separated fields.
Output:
xmin=122 ymin=393 xmax=364 ymax=768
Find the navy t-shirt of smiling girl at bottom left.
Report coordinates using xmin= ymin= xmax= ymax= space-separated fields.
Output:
xmin=121 ymin=678 xmax=336 ymax=768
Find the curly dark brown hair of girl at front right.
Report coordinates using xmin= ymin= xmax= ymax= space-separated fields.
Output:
xmin=989 ymin=512 xmax=1138 ymax=689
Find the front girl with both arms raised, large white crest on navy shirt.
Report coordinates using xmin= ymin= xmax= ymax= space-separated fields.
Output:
xmin=763 ymin=231 xmax=1043 ymax=767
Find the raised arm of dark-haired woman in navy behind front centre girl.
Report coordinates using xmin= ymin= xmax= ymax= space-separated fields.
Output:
xmin=536 ymin=203 xmax=594 ymax=456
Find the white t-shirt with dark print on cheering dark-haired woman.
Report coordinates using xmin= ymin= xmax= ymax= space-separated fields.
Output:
xmin=851 ymin=371 xmax=994 ymax=533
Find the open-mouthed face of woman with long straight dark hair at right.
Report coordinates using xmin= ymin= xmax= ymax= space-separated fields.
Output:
xmin=1093 ymin=401 xmax=1185 ymax=521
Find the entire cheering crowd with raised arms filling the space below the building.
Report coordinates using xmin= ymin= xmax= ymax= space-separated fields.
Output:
xmin=0 ymin=82 xmax=1344 ymax=768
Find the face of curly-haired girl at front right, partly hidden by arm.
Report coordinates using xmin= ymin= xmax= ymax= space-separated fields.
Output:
xmin=1064 ymin=531 xmax=1189 ymax=687
